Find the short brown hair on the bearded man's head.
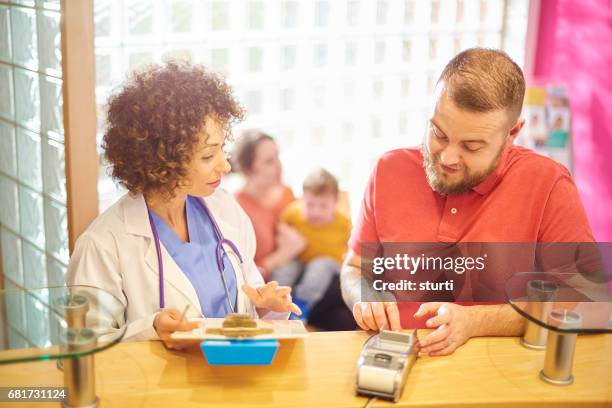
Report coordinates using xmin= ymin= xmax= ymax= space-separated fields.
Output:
xmin=438 ymin=48 xmax=525 ymax=122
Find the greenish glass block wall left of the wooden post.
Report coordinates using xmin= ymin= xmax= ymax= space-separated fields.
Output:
xmin=0 ymin=0 xmax=68 ymax=347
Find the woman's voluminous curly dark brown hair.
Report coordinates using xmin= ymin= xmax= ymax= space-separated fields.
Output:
xmin=102 ymin=62 xmax=244 ymax=197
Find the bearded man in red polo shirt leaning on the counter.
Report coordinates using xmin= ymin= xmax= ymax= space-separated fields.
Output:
xmin=341 ymin=48 xmax=594 ymax=355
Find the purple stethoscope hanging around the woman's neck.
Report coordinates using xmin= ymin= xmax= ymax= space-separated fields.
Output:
xmin=147 ymin=197 xmax=246 ymax=313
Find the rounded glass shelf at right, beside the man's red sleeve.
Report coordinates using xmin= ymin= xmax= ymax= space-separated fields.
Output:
xmin=505 ymin=272 xmax=612 ymax=333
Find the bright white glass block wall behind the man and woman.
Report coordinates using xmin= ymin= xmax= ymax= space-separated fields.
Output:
xmin=94 ymin=0 xmax=528 ymax=215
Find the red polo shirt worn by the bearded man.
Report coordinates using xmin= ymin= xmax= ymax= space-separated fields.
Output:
xmin=349 ymin=146 xmax=594 ymax=327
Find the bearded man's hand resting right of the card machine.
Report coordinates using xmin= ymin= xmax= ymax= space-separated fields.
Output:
xmin=414 ymin=302 xmax=474 ymax=356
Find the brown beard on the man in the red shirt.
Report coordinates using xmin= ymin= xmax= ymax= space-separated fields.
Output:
xmin=421 ymin=143 xmax=504 ymax=195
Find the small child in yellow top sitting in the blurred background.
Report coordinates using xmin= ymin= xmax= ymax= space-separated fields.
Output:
xmin=271 ymin=169 xmax=351 ymax=318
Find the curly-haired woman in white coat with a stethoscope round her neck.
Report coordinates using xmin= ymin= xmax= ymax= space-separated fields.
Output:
xmin=67 ymin=62 xmax=300 ymax=348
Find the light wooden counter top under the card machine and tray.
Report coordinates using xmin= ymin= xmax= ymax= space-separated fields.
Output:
xmin=0 ymin=332 xmax=612 ymax=408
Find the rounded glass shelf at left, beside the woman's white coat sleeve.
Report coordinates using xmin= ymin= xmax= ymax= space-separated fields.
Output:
xmin=0 ymin=286 xmax=126 ymax=364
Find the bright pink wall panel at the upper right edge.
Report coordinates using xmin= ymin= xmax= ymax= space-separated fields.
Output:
xmin=533 ymin=0 xmax=612 ymax=242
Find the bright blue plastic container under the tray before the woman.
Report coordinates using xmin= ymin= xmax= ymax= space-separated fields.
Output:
xmin=200 ymin=340 xmax=279 ymax=365
